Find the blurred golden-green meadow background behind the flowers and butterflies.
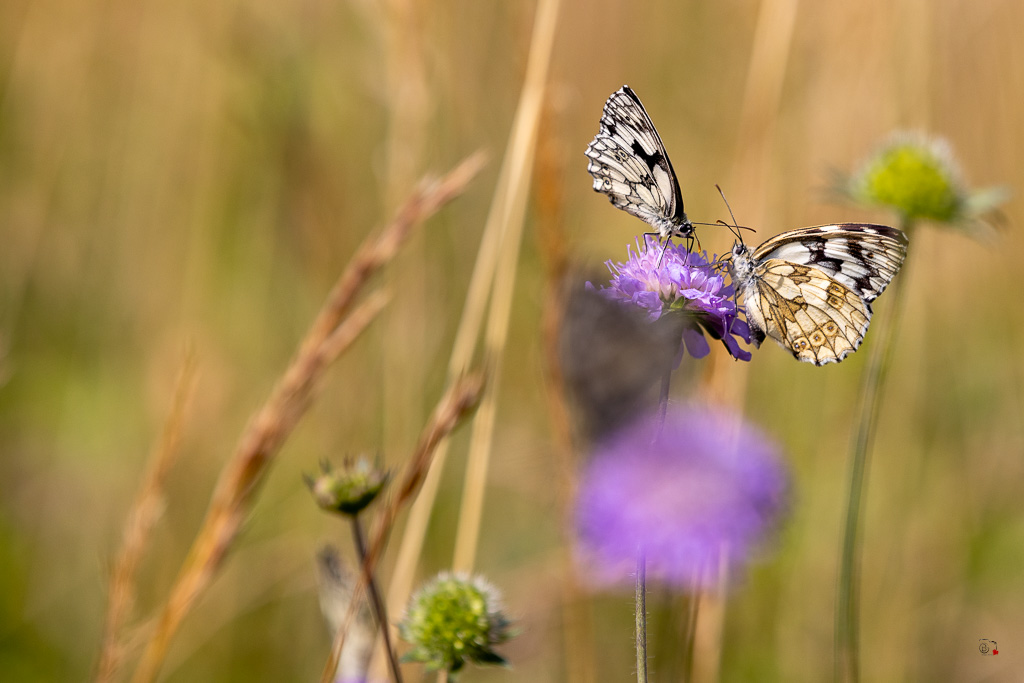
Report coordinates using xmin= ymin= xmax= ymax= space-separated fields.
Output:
xmin=0 ymin=0 xmax=1024 ymax=683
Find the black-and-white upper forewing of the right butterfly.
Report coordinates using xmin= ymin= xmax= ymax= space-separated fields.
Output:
xmin=753 ymin=223 xmax=907 ymax=302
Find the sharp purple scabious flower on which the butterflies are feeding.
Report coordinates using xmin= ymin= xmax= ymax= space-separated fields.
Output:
xmin=587 ymin=236 xmax=751 ymax=360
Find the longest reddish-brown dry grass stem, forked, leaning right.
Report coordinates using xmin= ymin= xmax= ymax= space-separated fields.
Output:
xmin=133 ymin=154 xmax=483 ymax=683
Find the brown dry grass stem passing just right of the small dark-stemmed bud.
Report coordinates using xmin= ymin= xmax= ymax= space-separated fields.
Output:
xmin=321 ymin=374 xmax=484 ymax=683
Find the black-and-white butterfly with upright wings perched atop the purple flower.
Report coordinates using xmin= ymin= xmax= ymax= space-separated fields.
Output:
xmin=586 ymin=85 xmax=693 ymax=241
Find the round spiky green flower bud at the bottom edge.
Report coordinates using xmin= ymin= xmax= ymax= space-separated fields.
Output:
xmin=398 ymin=571 xmax=512 ymax=673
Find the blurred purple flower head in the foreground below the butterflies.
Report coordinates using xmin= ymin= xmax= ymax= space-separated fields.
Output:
xmin=575 ymin=407 xmax=787 ymax=589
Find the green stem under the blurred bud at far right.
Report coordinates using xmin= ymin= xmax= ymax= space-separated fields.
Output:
xmin=834 ymin=221 xmax=910 ymax=683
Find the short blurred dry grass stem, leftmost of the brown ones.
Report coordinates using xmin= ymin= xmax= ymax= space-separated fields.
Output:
xmin=96 ymin=351 xmax=196 ymax=681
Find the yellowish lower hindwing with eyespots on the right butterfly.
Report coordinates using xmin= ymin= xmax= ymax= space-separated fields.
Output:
xmin=743 ymin=259 xmax=871 ymax=366
